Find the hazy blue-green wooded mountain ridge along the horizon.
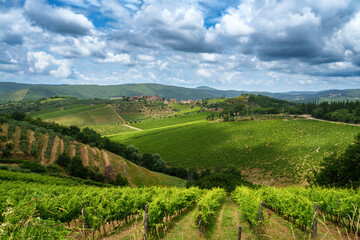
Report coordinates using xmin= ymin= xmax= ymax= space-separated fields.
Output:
xmin=0 ymin=82 xmax=360 ymax=102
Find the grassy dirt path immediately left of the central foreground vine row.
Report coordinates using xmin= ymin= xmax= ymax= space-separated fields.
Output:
xmin=163 ymin=204 xmax=204 ymax=240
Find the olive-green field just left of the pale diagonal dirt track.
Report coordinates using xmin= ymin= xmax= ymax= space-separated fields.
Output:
xmin=46 ymin=106 xmax=122 ymax=127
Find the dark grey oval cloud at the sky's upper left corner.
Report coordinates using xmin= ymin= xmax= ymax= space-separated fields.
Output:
xmin=24 ymin=0 xmax=94 ymax=35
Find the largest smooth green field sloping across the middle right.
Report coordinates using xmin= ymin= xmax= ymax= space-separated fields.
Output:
xmin=111 ymin=120 xmax=360 ymax=183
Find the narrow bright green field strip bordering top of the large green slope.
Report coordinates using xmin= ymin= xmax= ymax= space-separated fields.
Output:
xmin=131 ymin=112 xmax=213 ymax=129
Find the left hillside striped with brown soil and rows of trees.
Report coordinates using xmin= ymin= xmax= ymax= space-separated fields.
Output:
xmin=0 ymin=123 xmax=185 ymax=186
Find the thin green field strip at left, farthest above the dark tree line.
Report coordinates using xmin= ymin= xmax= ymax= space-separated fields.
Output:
xmin=30 ymin=104 xmax=105 ymax=120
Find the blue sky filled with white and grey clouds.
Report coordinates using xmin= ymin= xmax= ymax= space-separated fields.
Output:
xmin=0 ymin=0 xmax=360 ymax=92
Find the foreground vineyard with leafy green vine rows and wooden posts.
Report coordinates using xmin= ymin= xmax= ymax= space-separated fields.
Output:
xmin=0 ymin=170 xmax=360 ymax=239
